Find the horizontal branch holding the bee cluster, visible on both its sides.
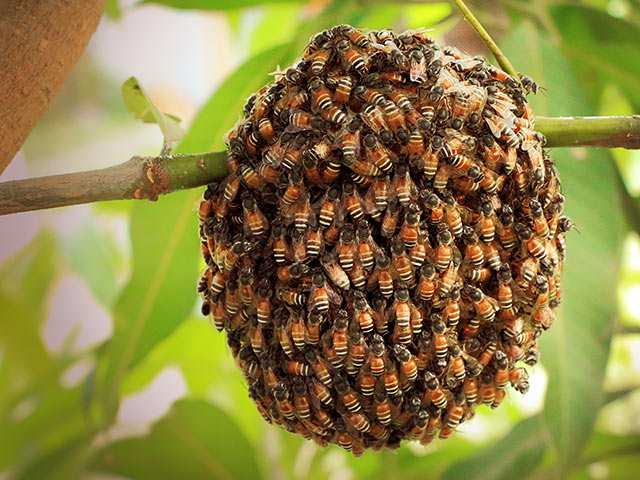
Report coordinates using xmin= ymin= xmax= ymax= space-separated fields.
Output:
xmin=0 ymin=116 xmax=640 ymax=215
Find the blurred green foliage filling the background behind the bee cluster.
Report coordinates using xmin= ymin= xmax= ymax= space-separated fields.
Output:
xmin=0 ymin=0 xmax=640 ymax=480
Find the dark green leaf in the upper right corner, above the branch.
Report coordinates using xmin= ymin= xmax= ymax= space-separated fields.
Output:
xmin=551 ymin=5 xmax=640 ymax=107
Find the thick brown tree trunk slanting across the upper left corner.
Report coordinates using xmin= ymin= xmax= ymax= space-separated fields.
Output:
xmin=0 ymin=0 xmax=104 ymax=173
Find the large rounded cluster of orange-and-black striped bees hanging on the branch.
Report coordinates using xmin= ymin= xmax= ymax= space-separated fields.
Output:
xmin=199 ymin=25 xmax=571 ymax=454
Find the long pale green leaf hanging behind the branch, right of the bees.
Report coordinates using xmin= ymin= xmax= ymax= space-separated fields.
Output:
xmin=504 ymin=23 xmax=623 ymax=470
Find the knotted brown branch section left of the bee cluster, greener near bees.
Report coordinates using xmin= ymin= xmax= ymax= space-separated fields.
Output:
xmin=0 ymin=152 xmax=226 ymax=215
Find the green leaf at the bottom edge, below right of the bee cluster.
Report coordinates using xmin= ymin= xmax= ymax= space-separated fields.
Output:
xmin=442 ymin=415 xmax=547 ymax=480
